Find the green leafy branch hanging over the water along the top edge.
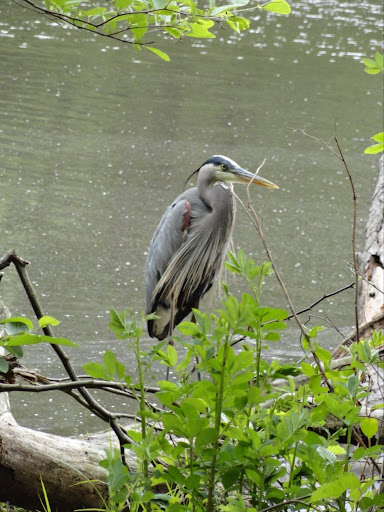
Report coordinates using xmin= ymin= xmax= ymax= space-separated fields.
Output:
xmin=22 ymin=0 xmax=291 ymax=61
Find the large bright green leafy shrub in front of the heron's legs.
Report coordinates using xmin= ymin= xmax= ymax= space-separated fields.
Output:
xmin=79 ymin=251 xmax=383 ymax=512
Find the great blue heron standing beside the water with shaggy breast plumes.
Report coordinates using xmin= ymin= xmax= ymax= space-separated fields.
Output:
xmin=146 ymin=155 xmax=278 ymax=340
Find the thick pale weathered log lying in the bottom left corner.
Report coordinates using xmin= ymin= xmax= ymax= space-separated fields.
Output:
xmin=0 ymin=302 xmax=108 ymax=512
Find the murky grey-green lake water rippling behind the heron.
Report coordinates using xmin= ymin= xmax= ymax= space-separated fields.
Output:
xmin=0 ymin=0 xmax=383 ymax=433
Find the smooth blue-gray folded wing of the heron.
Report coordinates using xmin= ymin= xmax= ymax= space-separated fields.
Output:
xmin=146 ymin=189 xmax=193 ymax=314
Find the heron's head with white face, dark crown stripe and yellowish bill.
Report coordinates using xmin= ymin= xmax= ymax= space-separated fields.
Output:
xmin=199 ymin=155 xmax=279 ymax=188
